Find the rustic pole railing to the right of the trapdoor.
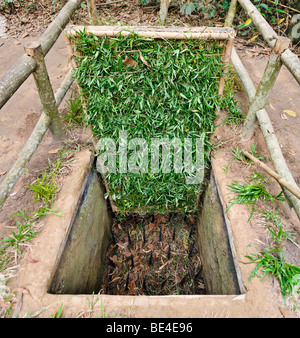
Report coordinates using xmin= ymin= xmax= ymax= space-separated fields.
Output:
xmin=225 ymin=0 xmax=300 ymax=219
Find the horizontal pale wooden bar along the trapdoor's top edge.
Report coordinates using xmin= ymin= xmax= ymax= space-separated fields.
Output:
xmin=65 ymin=26 xmax=236 ymax=40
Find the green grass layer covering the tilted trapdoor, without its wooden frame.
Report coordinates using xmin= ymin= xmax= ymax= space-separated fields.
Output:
xmin=75 ymin=33 xmax=238 ymax=213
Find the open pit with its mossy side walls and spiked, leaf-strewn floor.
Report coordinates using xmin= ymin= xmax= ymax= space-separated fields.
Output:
xmin=49 ymin=163 xmax=241 ymax=296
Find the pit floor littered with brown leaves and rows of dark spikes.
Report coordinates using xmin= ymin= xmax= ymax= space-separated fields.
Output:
xmin=101 ymin=213 xmax=205 ymax=295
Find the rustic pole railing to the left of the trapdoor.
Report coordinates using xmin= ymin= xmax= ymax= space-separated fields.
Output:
xmin=0 ymin=0 xmax=81 ymax=207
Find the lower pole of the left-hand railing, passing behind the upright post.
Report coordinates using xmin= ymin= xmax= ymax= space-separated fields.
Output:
xmin=0 ymin=69 xmax=73 ymax=207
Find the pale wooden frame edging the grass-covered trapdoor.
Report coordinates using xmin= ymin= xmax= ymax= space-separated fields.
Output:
xmin=65 ymin=26 xmax=236 ymax=213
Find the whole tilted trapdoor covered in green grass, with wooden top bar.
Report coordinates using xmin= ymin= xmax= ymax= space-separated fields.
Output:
xmin=67 ymin=27 xmax=238 ymax=213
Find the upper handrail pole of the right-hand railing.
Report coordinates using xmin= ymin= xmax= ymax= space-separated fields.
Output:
xmin=238 ymin=0 xmax=300 ymax=84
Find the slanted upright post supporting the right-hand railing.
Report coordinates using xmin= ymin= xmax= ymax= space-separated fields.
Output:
xmin=241 ymin=37 xmax=291 ymax=141
